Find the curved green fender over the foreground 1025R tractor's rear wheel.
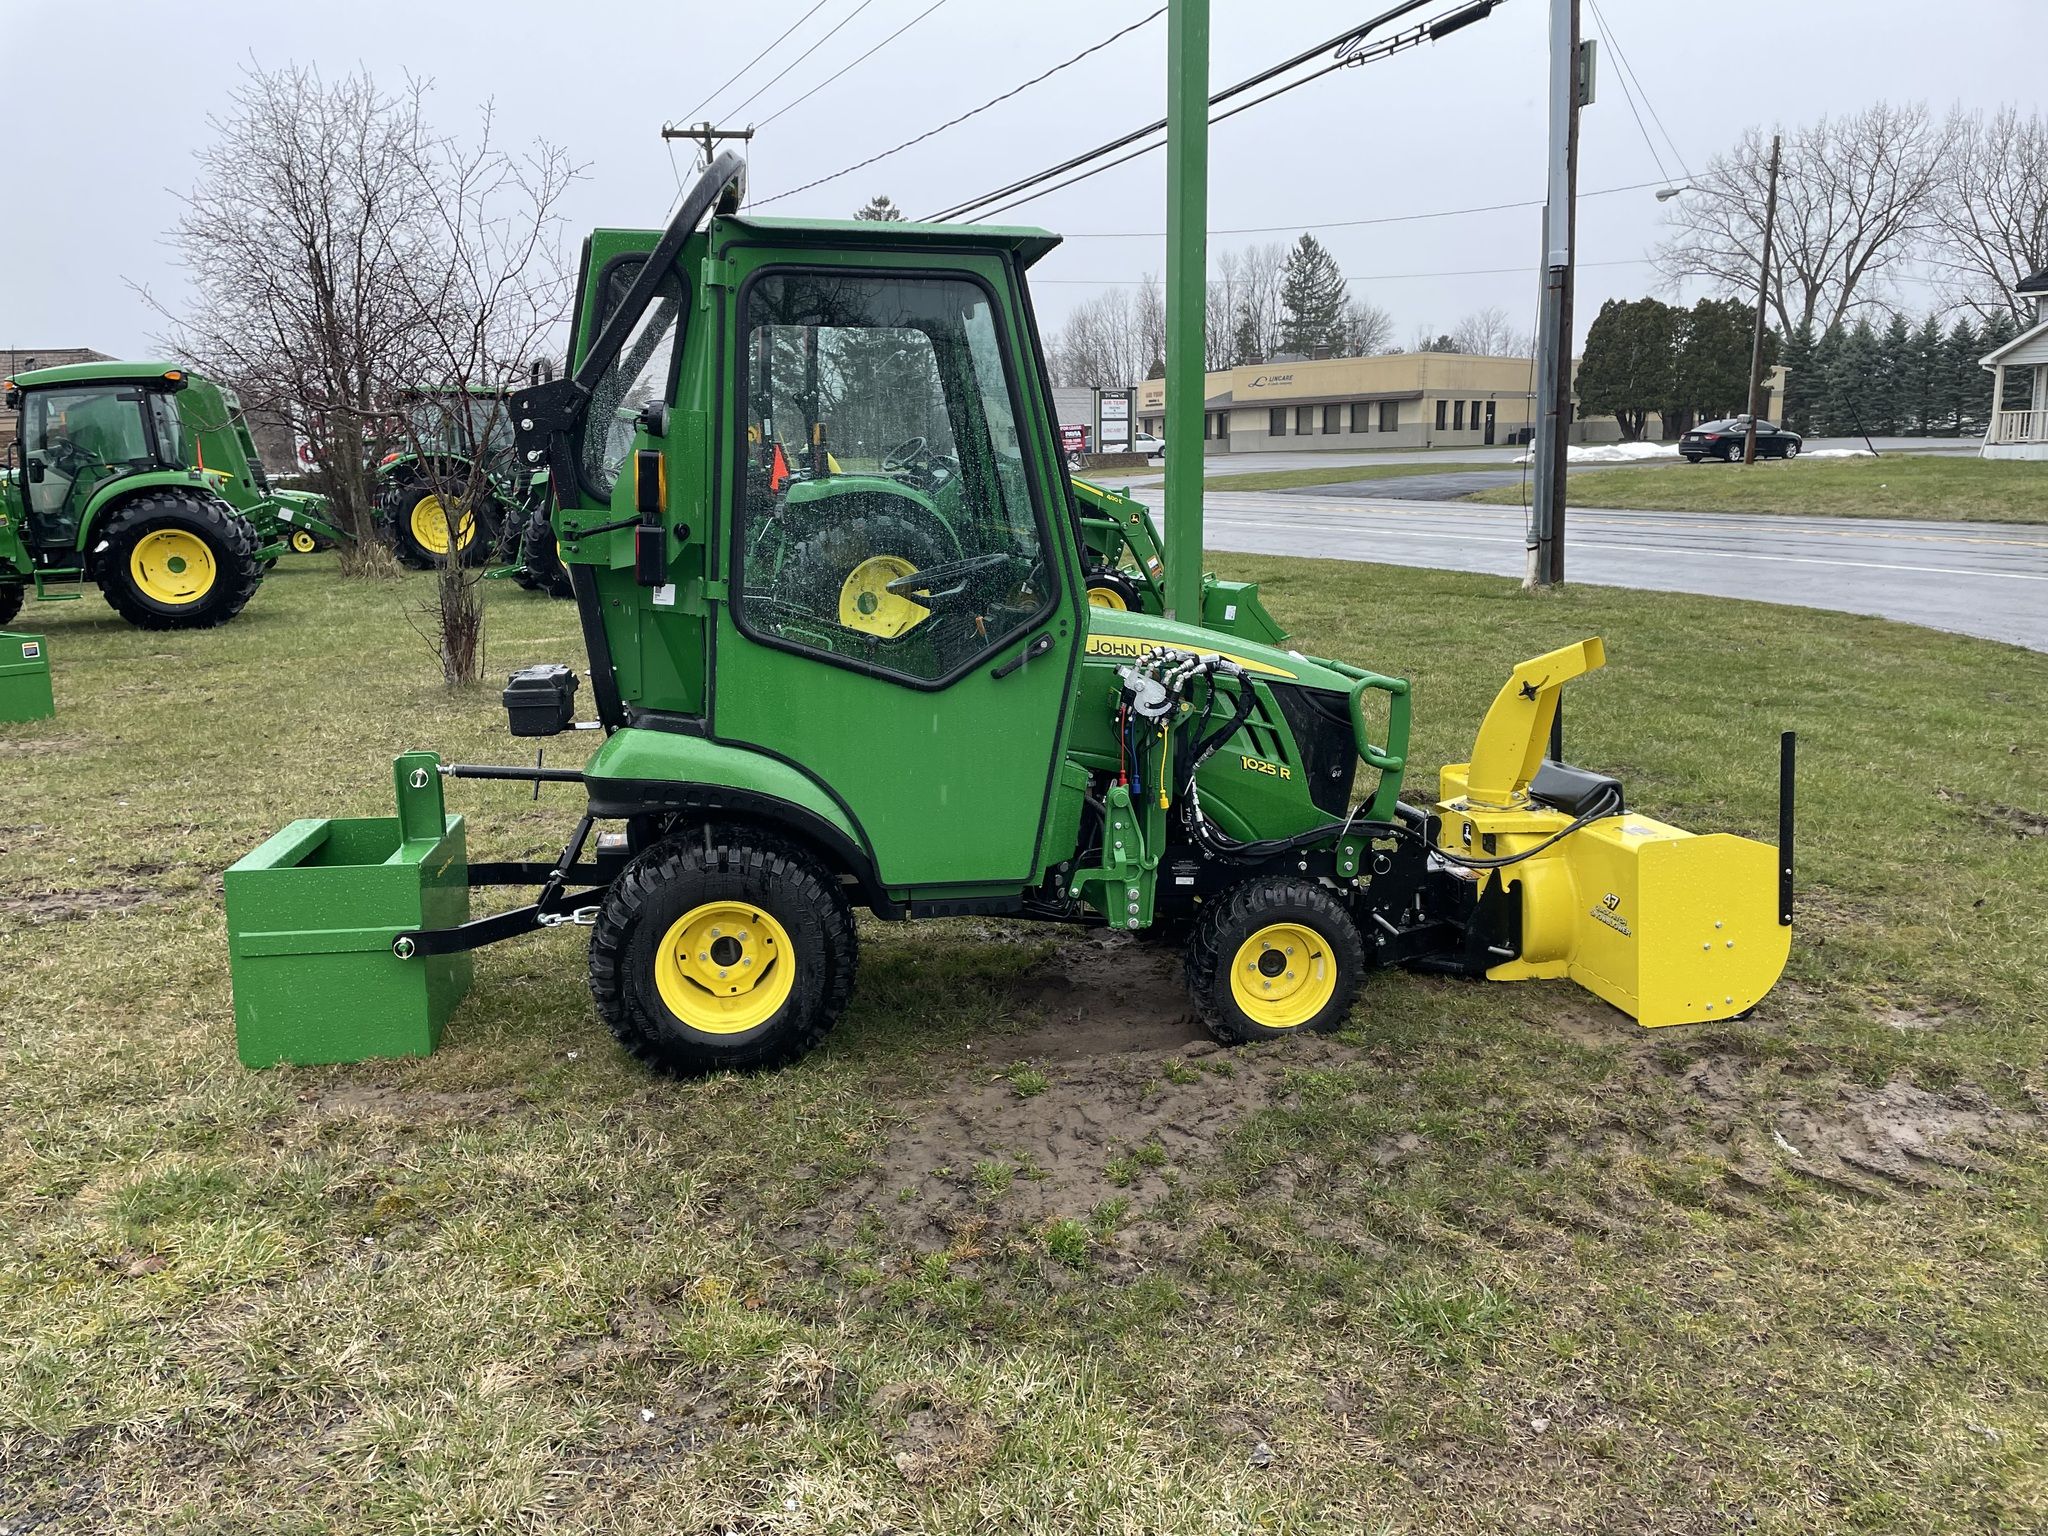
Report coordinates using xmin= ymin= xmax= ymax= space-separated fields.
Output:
xmin=584 ymin=727 xmax=877 ymax=887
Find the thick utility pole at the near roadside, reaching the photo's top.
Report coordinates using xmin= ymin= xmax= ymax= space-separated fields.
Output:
xmin=1528 ymin=0 xmax=1593 ymax=586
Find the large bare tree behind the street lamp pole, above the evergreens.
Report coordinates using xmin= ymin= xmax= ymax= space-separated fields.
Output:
xmin=1655 ymin=102 xmax=1946 ymax=336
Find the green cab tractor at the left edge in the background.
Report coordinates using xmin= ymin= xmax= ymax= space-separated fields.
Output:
xmin=0 ymin=362 xmax=268 ymax=629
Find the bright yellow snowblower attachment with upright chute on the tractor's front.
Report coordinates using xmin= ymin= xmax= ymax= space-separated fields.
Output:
xmin=1436 ymin=639 xmax=1792 ymax=1024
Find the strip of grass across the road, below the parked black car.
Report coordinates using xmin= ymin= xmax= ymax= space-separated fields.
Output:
xmin=1464 ymin=453 xmax=2048 ymax=522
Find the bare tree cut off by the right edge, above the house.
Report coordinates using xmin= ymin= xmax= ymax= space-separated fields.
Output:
xmin=1929 ymin=106 xmax=2048 ymax=319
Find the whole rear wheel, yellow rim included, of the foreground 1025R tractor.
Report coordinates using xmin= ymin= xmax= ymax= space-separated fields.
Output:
xmin=590 ymin=825 xmax=858 ymax=1077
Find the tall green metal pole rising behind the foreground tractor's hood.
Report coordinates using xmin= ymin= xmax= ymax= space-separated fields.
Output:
xmin=1165 ymin=0 xmax=1208 ymax=625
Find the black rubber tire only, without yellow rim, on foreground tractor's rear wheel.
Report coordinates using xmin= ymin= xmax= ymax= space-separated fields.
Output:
xmin=590 ymin=825 xmax=860 ymax=1077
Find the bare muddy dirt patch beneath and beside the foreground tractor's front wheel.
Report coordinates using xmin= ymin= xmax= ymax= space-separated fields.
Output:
xmin=782 ymin=938 xmax=1358 ymax=1257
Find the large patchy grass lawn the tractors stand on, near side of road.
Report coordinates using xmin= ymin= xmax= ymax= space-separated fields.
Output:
xmin=0 ymin=561 xmax=2048 ymax=1536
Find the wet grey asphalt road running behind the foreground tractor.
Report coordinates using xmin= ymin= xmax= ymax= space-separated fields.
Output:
xmin=1135 ymin=487 xmax=2048 ymax=651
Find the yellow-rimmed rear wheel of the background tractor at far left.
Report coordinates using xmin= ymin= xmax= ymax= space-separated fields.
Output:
xmin=94 ymin=489 xmax=262 ymax=629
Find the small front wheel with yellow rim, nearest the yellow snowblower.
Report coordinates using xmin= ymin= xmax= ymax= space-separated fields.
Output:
xmin=1186 ymin=877 xmax=1366 ymax=1044
